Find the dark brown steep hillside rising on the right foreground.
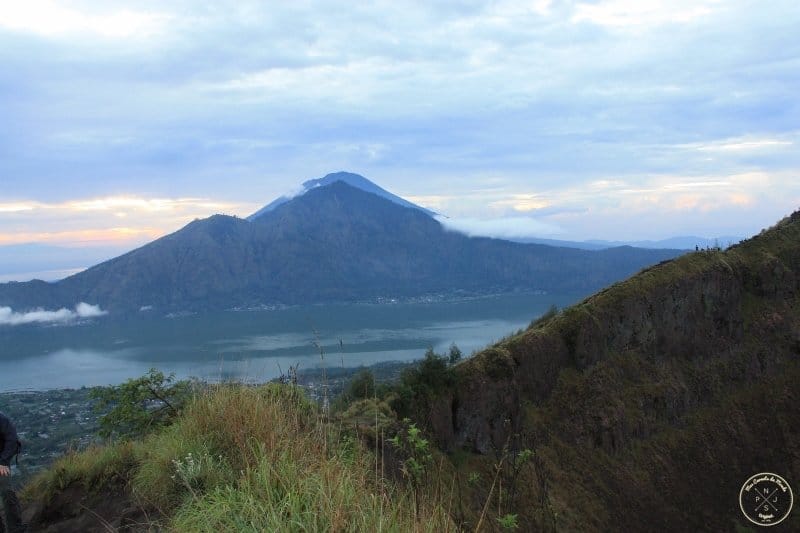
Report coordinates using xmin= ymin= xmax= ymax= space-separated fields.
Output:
xmin=428 ymin=212 xmax=800 ymax=531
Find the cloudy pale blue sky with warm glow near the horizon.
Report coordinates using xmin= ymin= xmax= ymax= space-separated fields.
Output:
xmin=0 ymin=0 xmax=800 ymax=262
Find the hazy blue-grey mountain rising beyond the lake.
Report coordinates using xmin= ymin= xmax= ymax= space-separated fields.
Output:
xmin=0 ymin=181 xmax=680 ymax=311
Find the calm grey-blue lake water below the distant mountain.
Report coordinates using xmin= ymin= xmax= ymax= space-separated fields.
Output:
xmin=0 ymin=294 xmax=580 ymax=392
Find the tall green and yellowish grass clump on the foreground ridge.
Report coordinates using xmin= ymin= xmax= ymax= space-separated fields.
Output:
xmin=23 ymin=384 xmax=455 ymax=532
